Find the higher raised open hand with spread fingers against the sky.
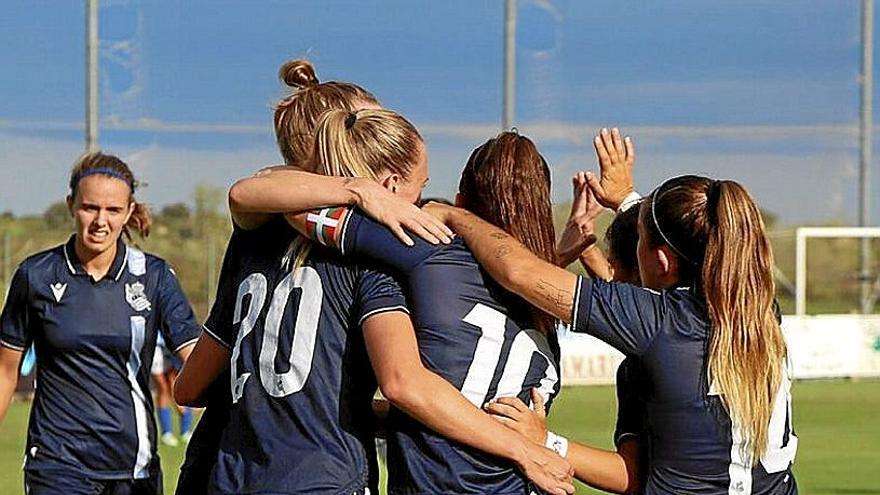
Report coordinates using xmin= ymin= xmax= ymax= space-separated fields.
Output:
xmin=587 ymin=127 xmax=636 ymax=210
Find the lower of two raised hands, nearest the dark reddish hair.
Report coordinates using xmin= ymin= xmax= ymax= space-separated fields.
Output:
xmin=556 ymin=172 xmax=604 ymax=267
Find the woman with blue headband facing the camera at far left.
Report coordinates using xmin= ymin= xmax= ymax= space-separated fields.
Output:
xmin=0 ymin=152 xmax=200 ymax=495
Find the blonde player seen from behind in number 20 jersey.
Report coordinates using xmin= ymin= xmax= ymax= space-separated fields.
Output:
xmin=177 ymin=110 xmax=573 ymax=493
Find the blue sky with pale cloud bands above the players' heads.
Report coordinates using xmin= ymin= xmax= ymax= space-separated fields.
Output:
xmin=0 ymin=0 xmax=880 ymax=224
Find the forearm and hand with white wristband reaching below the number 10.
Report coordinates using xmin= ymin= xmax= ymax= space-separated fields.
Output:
xmin=485 ymin=390 xmax=640 ymax=493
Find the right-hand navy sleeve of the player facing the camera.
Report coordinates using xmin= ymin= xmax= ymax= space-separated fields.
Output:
xmin=159 ymin=263 xmax=201 ymax=353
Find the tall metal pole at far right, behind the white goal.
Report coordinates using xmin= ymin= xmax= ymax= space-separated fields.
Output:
xmin=859 ymin=0 xmax=874 ymax=313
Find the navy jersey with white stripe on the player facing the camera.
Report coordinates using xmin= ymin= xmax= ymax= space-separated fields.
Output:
xmin=0 ymin=237 xmax=200 ymax=479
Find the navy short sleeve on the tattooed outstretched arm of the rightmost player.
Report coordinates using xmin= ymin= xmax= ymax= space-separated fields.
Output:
xmin=572 ymin=276 xmax=668 ymax=356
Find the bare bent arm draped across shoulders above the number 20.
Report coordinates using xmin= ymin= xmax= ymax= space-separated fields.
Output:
xmin=229 ymin=167 xmax=452 ymax=245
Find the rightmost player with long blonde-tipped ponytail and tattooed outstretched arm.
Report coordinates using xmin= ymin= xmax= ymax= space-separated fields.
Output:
xmin=432 ymin=131 xmax=797 ymax=494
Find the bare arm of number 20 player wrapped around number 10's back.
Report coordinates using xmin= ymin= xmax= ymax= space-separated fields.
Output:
xmin=363 ymin=311 xmax=574 ymax=495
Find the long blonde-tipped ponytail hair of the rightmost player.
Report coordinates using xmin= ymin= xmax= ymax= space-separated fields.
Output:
xmin=641 ymin=176 xmax=786 ymax=463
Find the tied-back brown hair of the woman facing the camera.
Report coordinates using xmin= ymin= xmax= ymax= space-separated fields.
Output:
xmin=68 ymin=151 xmax=153 ymax=240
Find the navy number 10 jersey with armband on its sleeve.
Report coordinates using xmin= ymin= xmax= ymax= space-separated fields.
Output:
xmin=342 ymin=212 xmax=559 ymax=494
